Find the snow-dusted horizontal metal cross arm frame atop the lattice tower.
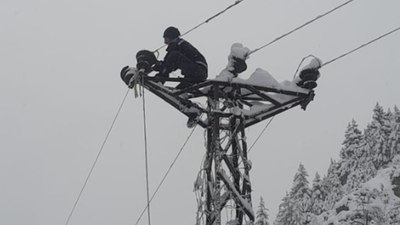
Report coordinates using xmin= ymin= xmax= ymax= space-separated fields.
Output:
xmin=141 ymin=76 xmax=315 ymax=128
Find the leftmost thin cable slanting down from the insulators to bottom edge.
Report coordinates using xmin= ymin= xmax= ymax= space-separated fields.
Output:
xmin=65 ymin=89 xmax=130 ymax=225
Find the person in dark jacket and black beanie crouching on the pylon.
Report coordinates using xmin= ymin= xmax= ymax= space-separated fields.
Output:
xmin=154 ymin=27 xmax=208 ymax=89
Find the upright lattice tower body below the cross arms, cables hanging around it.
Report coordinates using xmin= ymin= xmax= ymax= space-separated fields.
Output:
xmin=197 ymin=85 xmax=254 ymax=225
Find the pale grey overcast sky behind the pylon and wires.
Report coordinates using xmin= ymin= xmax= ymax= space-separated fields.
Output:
xmin=0 ymin=0 xmax=400 ymax=225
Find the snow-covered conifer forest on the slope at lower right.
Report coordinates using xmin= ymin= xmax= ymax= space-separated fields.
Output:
xmin=273 ymin=104 xmax=400 ymax=225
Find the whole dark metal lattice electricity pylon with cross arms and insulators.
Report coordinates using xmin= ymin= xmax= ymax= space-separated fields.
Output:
xmin=121 ymin=50 xmax=319 ymax=225
